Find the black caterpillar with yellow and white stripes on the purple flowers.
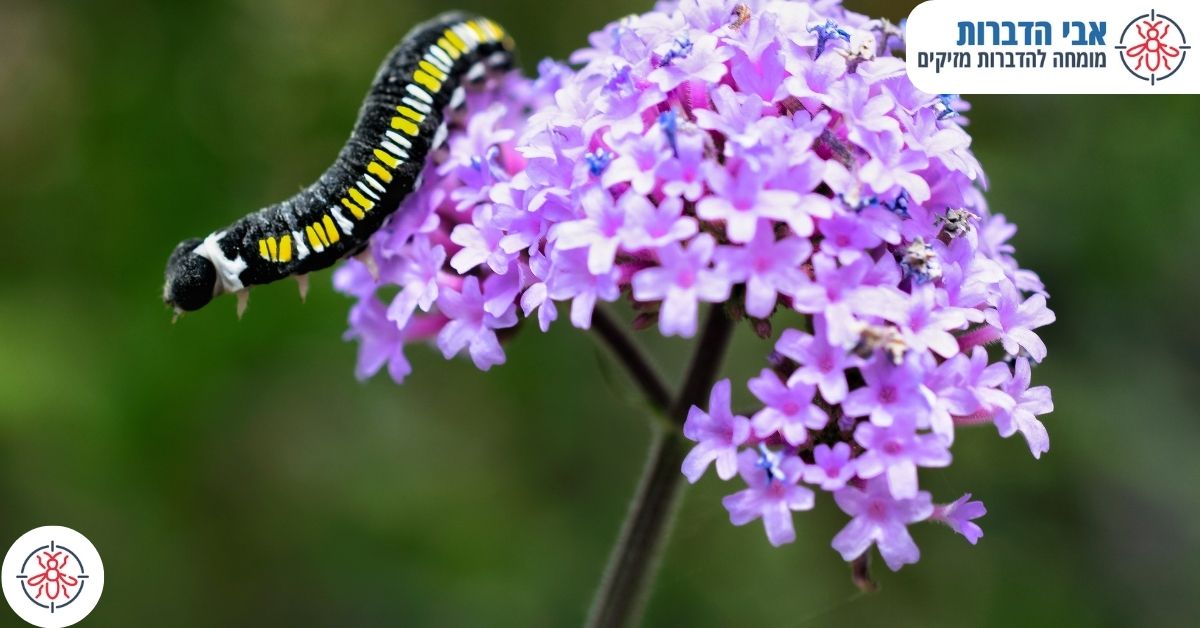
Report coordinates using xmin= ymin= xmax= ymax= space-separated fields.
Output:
xmin=163 ymin=12 xmax=514 ymax=315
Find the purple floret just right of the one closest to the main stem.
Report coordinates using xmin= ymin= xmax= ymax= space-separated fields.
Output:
xmin=750 ymin=369 xmax=829 ymax=445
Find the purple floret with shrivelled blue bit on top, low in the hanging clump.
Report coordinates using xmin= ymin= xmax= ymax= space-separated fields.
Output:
xmin=721 ymin=448 xmax=815 ymax=548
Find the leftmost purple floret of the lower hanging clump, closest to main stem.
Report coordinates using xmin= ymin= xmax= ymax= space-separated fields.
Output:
xmin=683 ymin=379 xmax=750 ymax=484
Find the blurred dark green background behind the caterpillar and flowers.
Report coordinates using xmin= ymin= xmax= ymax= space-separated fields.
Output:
xmin=0 ymin=0 xmax=1200 ymax=627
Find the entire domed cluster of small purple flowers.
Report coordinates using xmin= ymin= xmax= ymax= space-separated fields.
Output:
xmin=335 ymin=0 xmax=1054 ymax=569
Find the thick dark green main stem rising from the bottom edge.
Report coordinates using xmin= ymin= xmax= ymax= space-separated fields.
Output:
xmin=587 ymin=306 xmax=733 ymax=628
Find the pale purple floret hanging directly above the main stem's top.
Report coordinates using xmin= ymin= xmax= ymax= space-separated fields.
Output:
xmin=632 ymin=233 xmax=730 ymax=337
